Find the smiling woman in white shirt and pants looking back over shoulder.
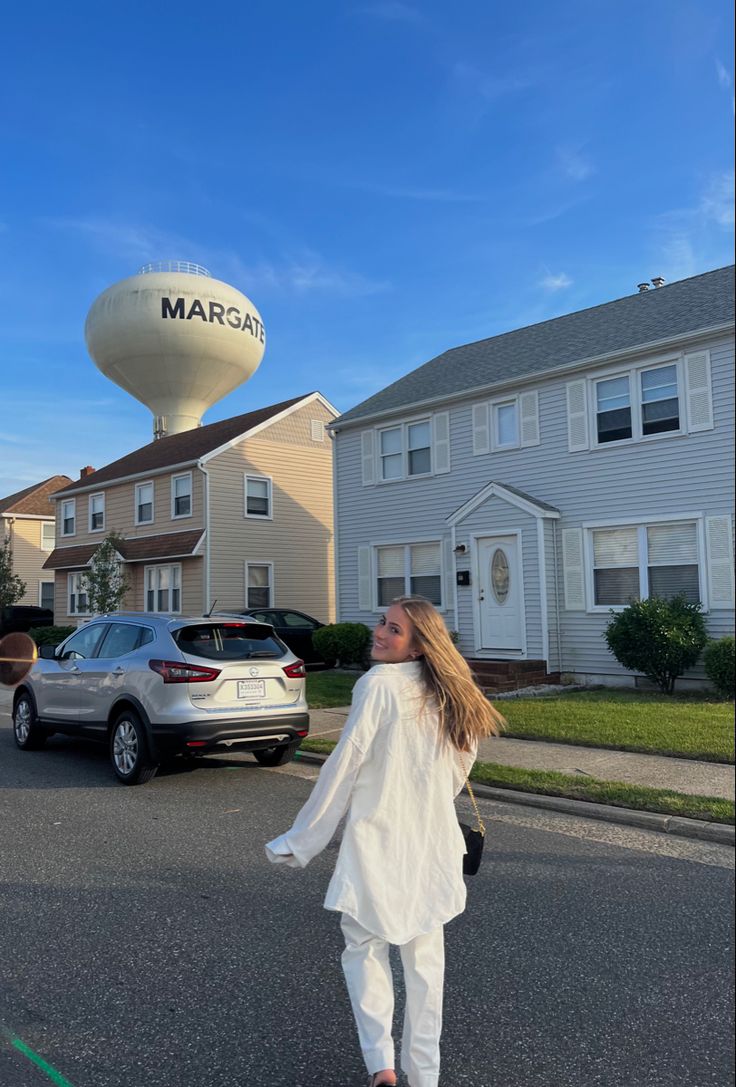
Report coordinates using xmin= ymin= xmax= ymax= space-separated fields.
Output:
xmin=266 ymin=597 xmax=502 ymax=1087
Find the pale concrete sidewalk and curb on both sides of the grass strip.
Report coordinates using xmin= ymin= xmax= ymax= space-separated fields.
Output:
xmin=302 ymin=705 xmax=736 ymax=845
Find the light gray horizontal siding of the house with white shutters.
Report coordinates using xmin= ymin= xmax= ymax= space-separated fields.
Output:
xmin=335 ymin=334 xmax=734 ymax=680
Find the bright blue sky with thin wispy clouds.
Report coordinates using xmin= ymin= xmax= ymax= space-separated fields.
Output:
xmin=0 ymin=0 xmax=734 ymax=497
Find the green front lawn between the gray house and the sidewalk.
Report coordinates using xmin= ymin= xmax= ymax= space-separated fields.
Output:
xmin=307 ymin=672 xmax=734 ymax=763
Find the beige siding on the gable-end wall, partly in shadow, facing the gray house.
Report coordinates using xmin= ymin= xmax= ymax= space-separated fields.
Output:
xmin=208 ymin=402 xmax=335 ymax=622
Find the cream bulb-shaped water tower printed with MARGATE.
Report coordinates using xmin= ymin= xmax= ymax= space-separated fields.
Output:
xmin=85 ymin=261 xmax=265 ymax=438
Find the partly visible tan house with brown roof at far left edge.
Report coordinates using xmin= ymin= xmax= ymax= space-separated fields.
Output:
xmin=0 ymin=475 xmax=72 ymax=608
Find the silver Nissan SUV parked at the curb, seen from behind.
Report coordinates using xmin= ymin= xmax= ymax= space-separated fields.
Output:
xmin=13 ymin=612 xmax=309 ymax=785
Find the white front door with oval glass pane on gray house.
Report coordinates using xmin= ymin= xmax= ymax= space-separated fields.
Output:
xmin=477 ymin=536 xmax=524 ymax=652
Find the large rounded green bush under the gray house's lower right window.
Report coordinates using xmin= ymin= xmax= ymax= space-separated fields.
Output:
xmin=603 ymin=597 xmax=708 ymax=695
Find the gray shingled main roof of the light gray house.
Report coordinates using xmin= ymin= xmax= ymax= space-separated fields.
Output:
xmin=336 ymin=264 xmax=734 ymax=426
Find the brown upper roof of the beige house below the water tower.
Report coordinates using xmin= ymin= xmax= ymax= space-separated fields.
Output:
xmin=55 ymin=392 xmax=330 ymax=495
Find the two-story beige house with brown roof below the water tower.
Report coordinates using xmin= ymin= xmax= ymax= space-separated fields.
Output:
xmin=45 ymin=392 xmax=337 ymax=624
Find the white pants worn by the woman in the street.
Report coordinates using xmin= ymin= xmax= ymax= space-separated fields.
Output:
xmin=340 ymin=913 xmax=445 ymax=1087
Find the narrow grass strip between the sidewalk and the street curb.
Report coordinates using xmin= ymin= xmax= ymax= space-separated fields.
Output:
xmin=302 ymin=739 xmax=735 ymax=826
